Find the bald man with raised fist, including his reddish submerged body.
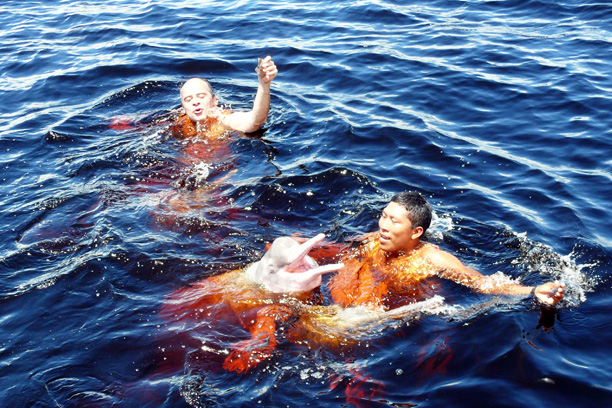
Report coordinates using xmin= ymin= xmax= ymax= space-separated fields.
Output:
xmin=110 ymin=56 xmax=278 ymax=220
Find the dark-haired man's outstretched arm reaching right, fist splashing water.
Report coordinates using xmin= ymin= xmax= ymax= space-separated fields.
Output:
xmin=427 ymin=249 xmax=565 ymax=305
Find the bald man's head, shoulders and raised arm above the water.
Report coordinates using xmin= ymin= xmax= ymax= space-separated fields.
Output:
xmin=175 ymin=56 xmax=278 ymax=138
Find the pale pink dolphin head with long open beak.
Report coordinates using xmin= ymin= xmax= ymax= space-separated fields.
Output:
xmin=247 ymin=234 xmax=344 ymax=293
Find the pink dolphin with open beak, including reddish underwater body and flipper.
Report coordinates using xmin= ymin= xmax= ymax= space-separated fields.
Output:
xmin=160 ymin=234 xmax=342 ymax=372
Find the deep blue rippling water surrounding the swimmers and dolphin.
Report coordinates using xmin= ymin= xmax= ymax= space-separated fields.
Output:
xmin=0 ymin=0 xmax=612 ymax=408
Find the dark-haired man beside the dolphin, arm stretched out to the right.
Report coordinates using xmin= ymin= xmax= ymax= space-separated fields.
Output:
xmin=322 ymin=192 xmax=565 ymax=309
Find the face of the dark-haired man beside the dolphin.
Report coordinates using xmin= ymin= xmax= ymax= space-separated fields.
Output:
xmin=378 ymin=202 xmax=421 ymax=252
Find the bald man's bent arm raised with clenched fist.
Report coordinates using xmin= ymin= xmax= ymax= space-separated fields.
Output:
xmin=221 ymin=56 xmax=278 ymax=133
